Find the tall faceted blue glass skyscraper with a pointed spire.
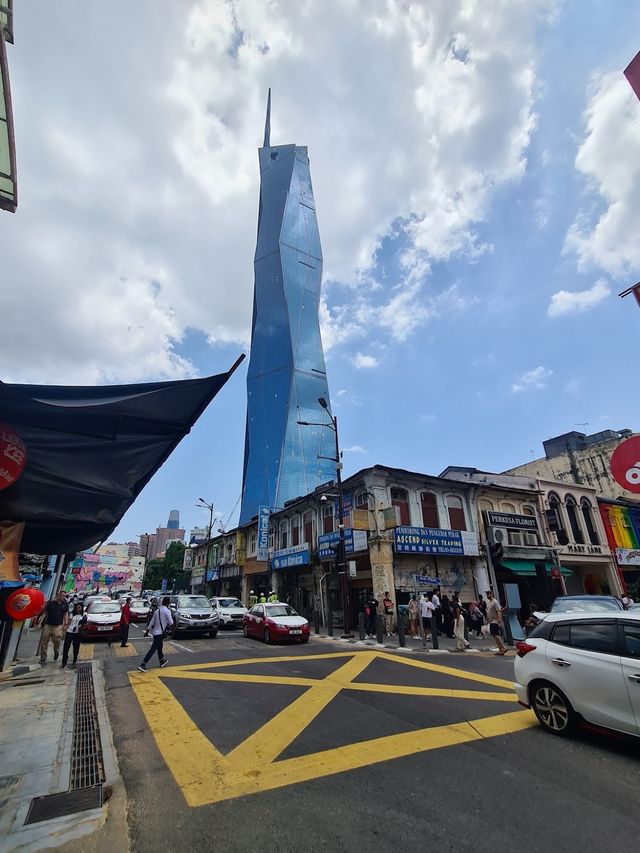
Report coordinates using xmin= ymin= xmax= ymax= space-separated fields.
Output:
xmin=240 ymin=92 xmax=335 ymax=524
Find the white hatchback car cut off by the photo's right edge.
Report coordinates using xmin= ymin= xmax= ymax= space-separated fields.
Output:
xmin=515 ymin=610 xmax=640 ymax=736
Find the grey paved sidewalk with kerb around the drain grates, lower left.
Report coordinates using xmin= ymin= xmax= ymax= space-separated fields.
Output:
xmin=0 ymin=629 xmax=128 ymax=853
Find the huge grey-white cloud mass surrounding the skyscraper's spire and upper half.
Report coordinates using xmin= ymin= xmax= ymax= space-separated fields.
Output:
xmin=0 ymin=0 xmax=554 ymax=382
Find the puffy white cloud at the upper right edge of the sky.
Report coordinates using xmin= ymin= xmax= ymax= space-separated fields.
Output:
xmin=565 ymin=71 xmax=640 ymax=278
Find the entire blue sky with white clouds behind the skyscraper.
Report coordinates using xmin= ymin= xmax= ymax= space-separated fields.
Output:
xmin=0 ymin=0 xmax=640 ymax=539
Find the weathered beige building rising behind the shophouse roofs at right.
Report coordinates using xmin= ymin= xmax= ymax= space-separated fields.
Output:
xmin=504 ymin=429 xmax=635 ymax=499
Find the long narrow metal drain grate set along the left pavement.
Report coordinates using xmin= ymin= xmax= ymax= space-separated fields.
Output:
xmin=69 ymin=664 xmax=104 ymax=791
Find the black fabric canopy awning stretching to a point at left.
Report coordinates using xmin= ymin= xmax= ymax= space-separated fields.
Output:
xmin=0 ymin=356 xmax=244 ymax=554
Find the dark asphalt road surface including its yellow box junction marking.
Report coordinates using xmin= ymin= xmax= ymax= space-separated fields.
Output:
xmin=105 ymin=631 xmax=640 ymax=853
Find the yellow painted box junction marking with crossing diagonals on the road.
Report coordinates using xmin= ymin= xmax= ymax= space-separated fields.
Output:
xmin=129 ymin=651 xmax=536 ymax=806
